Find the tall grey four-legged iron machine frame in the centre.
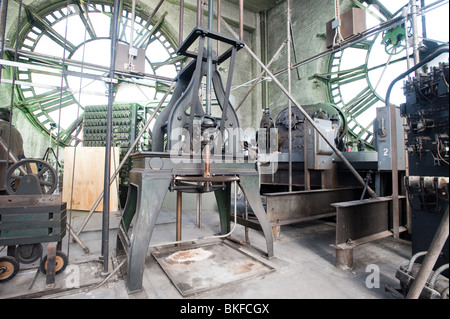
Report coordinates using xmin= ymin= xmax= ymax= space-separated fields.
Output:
xmin=117 ymin=2 xmax=274 ymax=292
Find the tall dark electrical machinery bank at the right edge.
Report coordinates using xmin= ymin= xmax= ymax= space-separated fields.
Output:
xmin=396 ymin=60 xmax=450 ymax=299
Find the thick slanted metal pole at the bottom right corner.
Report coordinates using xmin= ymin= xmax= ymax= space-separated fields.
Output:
xmin=406 ymin=206 xmax=449 ymax=299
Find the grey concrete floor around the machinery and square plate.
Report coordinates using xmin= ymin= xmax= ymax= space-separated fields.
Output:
xmin=0 ymin=211 xmax=411 ymax=300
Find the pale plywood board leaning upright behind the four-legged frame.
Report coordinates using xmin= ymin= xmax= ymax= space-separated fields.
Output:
xmin=62 ymin=147 xmax=120 ymax=212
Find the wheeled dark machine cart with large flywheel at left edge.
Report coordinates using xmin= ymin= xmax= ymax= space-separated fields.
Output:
xmin=0 ymin=140 xmax=68 ymax=288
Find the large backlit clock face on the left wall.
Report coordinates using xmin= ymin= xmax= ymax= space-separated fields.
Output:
xmin=16 ymin=0 xmax=184 ymax=145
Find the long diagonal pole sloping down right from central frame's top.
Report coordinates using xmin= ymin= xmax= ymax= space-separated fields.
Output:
xmin=222 ymin=19 xmax=378 ymax=198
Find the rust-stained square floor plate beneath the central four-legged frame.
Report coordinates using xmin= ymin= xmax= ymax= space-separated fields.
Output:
xmin=152 ymin=242 xmax=274 ymax=297
